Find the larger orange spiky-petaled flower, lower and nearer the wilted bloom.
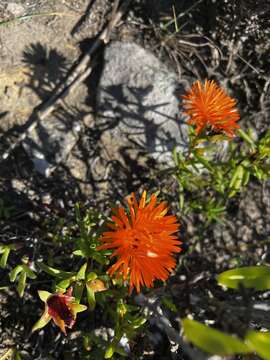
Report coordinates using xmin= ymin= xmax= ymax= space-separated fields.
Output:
xmin=99 ymin=191 xmax=181 ymax=293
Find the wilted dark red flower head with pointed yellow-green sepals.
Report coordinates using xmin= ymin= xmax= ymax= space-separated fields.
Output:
xmin=32 ymin=288 xmax=87 ymax=335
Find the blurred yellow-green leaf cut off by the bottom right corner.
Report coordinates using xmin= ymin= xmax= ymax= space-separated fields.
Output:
xmin=245 ymin=331 xmax=270 ymax=360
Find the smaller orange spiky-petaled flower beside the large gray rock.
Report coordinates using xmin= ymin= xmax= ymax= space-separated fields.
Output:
xmin=182 ymin=80 xmax=240 ymax=137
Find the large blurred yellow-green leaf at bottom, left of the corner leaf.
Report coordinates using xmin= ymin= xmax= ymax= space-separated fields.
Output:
xmin=182 ymin=319 xmax=250 ymax=356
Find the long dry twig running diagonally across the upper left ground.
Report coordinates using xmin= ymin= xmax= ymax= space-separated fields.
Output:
xmin=2 ymin=0 xmax=130 ymax=159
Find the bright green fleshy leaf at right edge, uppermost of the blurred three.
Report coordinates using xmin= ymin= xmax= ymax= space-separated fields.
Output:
xmin=218 ymin=266 xmax=270 ymax=290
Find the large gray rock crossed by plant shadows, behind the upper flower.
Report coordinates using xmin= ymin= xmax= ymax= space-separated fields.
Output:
xmin=96 ymin=42 xmax=187 ymax=162
